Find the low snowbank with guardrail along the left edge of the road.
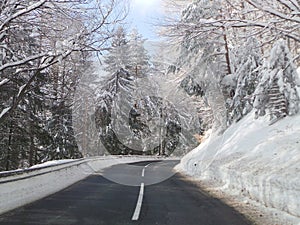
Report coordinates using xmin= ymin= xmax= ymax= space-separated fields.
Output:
xmin=0 ymin=156 xmax=159 ymax=214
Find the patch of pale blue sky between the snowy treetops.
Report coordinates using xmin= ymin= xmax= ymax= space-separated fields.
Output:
xmin=126 ymin=0 xmax=163 ymax=40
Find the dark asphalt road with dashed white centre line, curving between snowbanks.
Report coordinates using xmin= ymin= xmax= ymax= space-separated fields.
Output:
xmin=0 ymin=161 xmax=251 ymax=225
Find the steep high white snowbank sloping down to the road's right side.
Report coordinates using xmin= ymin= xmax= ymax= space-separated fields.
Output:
xmin=177 ymin=114 xmax=300 ymax=224
